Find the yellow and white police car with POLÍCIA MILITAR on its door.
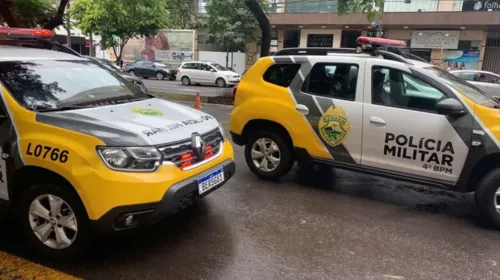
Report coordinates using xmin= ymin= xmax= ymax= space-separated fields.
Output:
xmin=230 ymin=37 xmax=500 ymax=226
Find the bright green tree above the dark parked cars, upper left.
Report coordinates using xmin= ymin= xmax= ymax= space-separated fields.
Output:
xmin=70 ymin=0 xmax=169 ymax=63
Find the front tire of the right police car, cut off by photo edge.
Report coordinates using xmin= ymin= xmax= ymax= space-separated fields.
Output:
xmin=475 ymin=168 xmax=500 ymax=229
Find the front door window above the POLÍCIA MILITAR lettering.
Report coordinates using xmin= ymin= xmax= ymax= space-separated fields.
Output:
xmin=372 ymin=67 xmax=445 ymax=112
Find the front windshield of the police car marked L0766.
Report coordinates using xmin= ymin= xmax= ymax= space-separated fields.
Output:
xmin=0 ymin=60 xmax=150 ymax=110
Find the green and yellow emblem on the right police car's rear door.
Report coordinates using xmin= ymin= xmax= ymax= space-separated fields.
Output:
xmin=318 ymin=106 xmax=351 ymax=147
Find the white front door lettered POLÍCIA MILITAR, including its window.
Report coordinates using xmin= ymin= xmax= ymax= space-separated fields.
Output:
xmin=361 ymin=59 xmax=472 ymax=183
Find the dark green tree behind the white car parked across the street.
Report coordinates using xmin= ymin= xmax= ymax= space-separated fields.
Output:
xmin=198 ymin=0 xmax=266 ymax=67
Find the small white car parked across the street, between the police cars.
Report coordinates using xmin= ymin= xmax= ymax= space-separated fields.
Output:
xmin=177 ymin=61 xmax=241 ymax=87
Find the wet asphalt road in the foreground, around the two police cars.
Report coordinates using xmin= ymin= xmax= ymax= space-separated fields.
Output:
xmin=0 ymin=106 xmax=500 ymax=280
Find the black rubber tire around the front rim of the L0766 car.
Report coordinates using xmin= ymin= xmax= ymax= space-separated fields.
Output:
xmin=19 ymin=184 xmax=91 ymax=261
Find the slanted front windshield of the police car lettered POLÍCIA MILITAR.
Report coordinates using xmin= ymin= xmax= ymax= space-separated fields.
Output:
xmin=425 ymin=67 xmax=498 ymax=106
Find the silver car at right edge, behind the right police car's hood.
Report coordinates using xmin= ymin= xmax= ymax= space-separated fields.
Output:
xmin=450 ymin=70 xmax=500 ymax=96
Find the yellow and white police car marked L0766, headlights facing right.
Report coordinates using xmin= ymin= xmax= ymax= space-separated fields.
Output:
xmin=0 ymin=29 xmax=235 ymax=258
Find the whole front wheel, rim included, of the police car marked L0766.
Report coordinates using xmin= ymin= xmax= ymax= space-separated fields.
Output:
xmin=19 ymin=184 xmax=91 ymax=260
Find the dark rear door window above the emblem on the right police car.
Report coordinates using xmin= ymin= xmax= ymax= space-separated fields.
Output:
xmin=302 ymin=63 xmax=358 ymax=101
